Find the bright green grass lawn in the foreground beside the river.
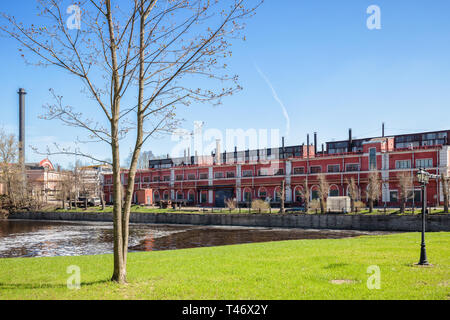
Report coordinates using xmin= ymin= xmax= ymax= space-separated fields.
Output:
xmin=0 ymin=233 xmax=450 ymax=300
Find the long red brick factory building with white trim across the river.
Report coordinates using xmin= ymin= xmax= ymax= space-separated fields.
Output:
xmin=104 ymin=131 xmax=450 ymax=207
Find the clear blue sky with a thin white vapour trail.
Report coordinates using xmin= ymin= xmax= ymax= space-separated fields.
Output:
xmin=0 ymin=0 xmax=450 ymax=165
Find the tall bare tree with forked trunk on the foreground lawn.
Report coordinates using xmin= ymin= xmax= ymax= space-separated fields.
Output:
xmin=0 ymin=0 xmax=260 ymax=283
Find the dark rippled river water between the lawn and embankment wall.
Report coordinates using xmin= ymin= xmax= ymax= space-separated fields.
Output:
xmin=0 ymin=220 xmax=386 ymax=258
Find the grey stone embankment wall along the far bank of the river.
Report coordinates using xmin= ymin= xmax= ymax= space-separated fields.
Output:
xmin=9 ymin=212 xmax=450 ymax=232
